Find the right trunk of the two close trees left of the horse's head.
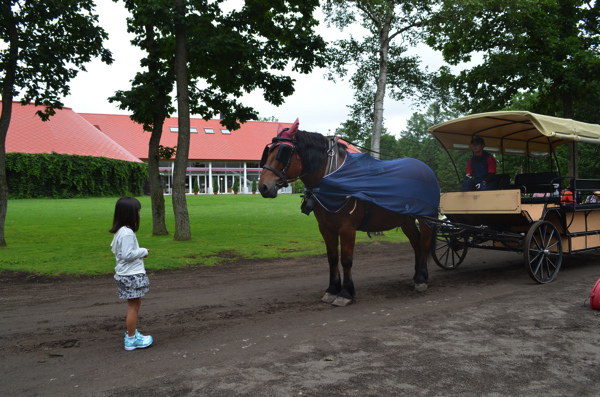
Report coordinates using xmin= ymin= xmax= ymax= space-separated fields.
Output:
xmin=173 ymin=0 xmax=192 ymax=241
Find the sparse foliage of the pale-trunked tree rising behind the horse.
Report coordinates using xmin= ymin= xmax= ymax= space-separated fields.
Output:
xmin=323 ymin=0 xmax=434 ymax=156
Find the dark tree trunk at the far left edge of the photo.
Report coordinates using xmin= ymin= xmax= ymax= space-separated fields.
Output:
xmin=0 ymin=24 xmax=18 ymax=247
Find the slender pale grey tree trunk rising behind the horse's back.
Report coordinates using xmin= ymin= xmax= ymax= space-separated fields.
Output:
xmin=371 ymin=16 xmax=392 ymax=159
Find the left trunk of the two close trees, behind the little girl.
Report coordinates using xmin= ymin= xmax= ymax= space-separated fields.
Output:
xmin=146 ymin=25 xmax=169 ymax=236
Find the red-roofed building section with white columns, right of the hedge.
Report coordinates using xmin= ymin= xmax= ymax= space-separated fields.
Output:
xmin=79 ymin=113 xmax=292 ymax=194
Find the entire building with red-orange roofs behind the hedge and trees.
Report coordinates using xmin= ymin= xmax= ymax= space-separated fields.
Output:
xmin=6 ymin=102 xmax=358 ymax=194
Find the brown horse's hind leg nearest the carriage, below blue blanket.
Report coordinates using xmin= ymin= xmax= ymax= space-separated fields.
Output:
xmin=402 ymin=219 xmax=433 ymax=292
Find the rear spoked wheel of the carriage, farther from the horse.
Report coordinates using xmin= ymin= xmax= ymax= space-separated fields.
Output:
xmin=523 ymin=221 xmax=562 ymax=284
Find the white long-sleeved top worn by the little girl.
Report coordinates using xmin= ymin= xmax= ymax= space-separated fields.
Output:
xmin=110 ymin=226 xmax=148 ymax=276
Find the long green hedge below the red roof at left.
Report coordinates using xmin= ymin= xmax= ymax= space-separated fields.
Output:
xmin=6 ymin=153 xmax=148 ymax=198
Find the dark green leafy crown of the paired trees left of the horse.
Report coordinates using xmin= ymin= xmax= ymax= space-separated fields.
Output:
xmin=113 ymin=0 xmax=325 ymax=241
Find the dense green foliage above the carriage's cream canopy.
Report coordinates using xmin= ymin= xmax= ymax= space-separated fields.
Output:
xmin=427 ymin=0 xmax=600 ymax=123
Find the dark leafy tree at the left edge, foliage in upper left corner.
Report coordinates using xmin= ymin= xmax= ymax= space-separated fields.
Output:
xmin=0 ymin=0 xmax=112 ymax=246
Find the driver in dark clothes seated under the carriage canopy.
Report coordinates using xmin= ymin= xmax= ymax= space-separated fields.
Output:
xmin=460 ymin=136 xmax=498 ymax=192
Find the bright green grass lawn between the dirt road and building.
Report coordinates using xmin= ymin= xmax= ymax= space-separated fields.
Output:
xmin=0 ymin=194 xmax=406 ymax=275
